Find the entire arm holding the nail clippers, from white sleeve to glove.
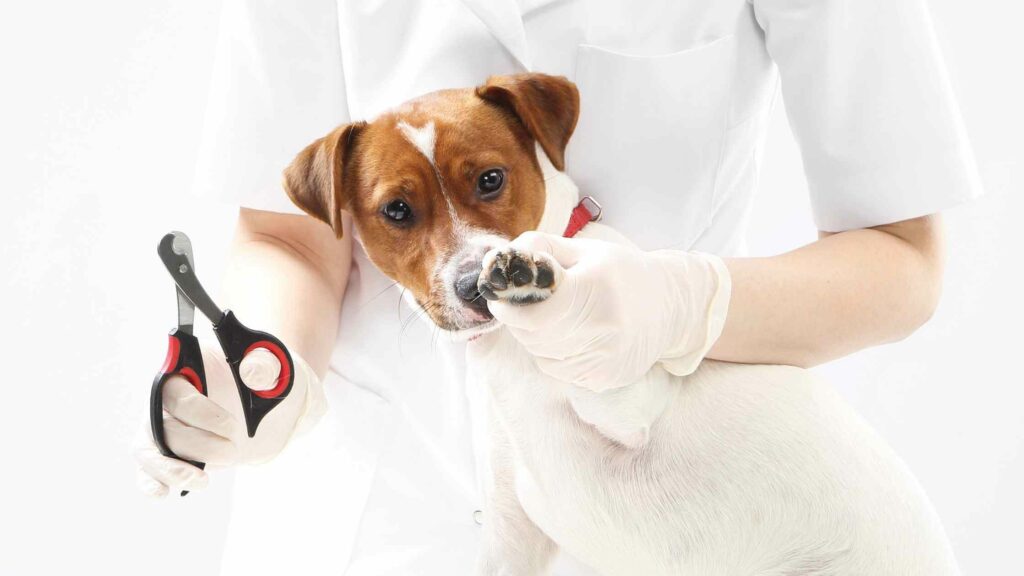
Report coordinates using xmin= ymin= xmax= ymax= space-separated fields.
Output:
xmin=136 ymin=0 xmax=351 ymax=496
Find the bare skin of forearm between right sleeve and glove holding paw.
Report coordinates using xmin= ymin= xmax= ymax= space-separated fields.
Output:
xmin=708 ymin=216 xmax=943 ymax=367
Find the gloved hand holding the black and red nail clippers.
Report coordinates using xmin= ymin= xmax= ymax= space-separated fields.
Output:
xmin=135 ymin=342 xmax=327 ymax=496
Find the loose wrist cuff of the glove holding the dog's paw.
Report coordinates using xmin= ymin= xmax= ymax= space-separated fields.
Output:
xmin=655 ymin=250 xmax=732 ymax=376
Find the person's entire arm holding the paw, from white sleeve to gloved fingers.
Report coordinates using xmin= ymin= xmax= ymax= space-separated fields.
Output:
xmin=490 ymin=0 xmax=981 ymax=389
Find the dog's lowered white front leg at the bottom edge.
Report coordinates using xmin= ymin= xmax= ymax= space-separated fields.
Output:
xmin=476 ymin=399 xmax=558 ymax=576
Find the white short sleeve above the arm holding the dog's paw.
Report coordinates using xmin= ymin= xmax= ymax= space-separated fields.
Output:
xmin=753 ymin=0 xmax=981 ymax=232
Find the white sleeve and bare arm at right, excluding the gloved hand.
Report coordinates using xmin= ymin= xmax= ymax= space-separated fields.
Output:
xmin=729 ymin=0 xmax=981 ymax=366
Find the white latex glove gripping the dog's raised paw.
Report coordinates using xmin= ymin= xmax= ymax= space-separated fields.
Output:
xmin=487 ymin=233 xmax=731 ymax=392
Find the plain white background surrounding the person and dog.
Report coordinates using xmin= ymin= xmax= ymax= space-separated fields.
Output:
xmin=0 ymin=0 xmax=1024 ymax=576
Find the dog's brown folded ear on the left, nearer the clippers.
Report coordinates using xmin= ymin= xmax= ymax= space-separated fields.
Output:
xmin=285 ymin=122 xmax=367 ymax=238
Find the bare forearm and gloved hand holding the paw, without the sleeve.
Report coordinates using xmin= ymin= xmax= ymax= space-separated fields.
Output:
xmin=488 ymin=216 xmax=943 ymax=390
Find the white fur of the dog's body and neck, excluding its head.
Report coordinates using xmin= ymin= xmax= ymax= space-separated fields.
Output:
xmin=467 ymin=148 xmax=957 ymax=576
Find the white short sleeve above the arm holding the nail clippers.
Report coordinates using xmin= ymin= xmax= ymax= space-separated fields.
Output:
xmin=194 ymin=0 xmax=348 ymax=213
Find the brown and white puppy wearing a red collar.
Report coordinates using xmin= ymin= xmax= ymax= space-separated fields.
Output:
xmin=285 ymin=74 xmax=957 ymax=576
